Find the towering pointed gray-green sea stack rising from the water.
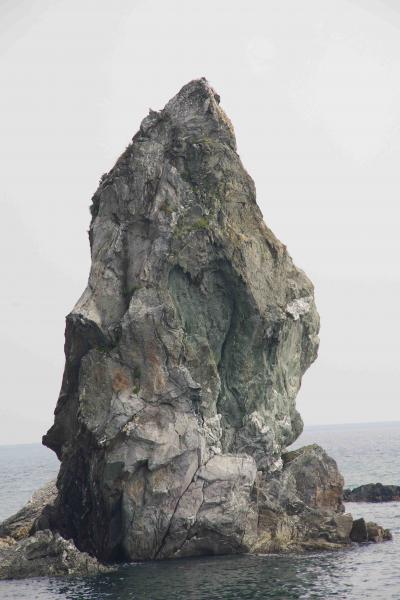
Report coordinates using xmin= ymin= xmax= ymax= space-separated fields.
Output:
xmin=0 ymin=79 xmax=390 ymax=580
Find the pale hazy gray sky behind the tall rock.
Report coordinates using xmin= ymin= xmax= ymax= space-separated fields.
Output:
xmin=0 ymin=0 xmax=400 ymax=444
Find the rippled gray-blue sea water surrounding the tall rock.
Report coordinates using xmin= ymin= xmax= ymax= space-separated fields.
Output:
xmin=0 ymin=423 xmax=400 ymax=600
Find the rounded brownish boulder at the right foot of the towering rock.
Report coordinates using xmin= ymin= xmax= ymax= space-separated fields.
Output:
xmin=253 ymin=444 xmax=353 ymax=553
